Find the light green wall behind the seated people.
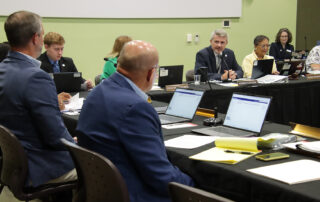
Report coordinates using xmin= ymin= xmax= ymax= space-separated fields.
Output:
xmin=0 ymin=0 xmax=297 ymax=80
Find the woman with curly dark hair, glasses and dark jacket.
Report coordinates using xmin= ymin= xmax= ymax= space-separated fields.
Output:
xmin=269 ymin=28 xmax=294 ymax=60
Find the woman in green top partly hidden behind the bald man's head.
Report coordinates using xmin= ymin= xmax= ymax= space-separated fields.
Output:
xmin=100 ymin=36 xmax=132 ymax=80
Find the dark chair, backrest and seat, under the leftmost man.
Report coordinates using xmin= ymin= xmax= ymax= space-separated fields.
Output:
xmin=0 ymin=125 xmax=77 ymax=201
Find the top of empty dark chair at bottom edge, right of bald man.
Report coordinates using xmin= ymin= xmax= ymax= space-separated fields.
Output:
xmin=169 ymin=182 xmax=232 ymax=202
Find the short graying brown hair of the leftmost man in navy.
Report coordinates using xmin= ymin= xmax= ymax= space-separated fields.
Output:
xmin=4 ymin=11 xmax=42 ymax=47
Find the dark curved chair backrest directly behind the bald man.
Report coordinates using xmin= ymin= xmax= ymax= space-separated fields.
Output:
xmin=61 ymin=139 xmax=129 ymax=202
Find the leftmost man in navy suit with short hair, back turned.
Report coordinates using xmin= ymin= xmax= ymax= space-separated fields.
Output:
xmin=0 ymin=11 xmax=76 ymax=198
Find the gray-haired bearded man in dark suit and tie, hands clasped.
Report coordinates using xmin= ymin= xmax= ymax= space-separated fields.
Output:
xmin=194 ymin=29 xmax=243 ymax=80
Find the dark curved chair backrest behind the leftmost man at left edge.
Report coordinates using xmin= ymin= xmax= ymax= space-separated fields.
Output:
xmin=0 ymin=125 xmax=28 ymax=198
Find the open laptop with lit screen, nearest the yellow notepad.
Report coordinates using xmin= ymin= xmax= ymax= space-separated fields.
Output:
xmin=192 ymin=93 xmax=271 ymax=137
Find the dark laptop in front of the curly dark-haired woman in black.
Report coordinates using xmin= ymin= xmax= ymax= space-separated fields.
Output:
xmin=278 ymin=59 xmax=305 ymax=76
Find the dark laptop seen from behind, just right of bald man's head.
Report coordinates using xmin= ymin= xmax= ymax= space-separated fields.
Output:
xmin=158 ymin=65 xmax=183 ymax=88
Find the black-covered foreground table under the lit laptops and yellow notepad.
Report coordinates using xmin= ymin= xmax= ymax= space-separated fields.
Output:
xmin=63 ymin=96 xmax=320 ymax=202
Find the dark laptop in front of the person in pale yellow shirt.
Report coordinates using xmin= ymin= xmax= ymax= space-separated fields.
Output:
xmin=251 ymin=59 xmax=274 ymax=79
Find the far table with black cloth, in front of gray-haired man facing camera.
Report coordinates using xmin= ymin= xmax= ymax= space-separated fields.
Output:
xmin=148 ymin=77 xmax=320 ymax=127
